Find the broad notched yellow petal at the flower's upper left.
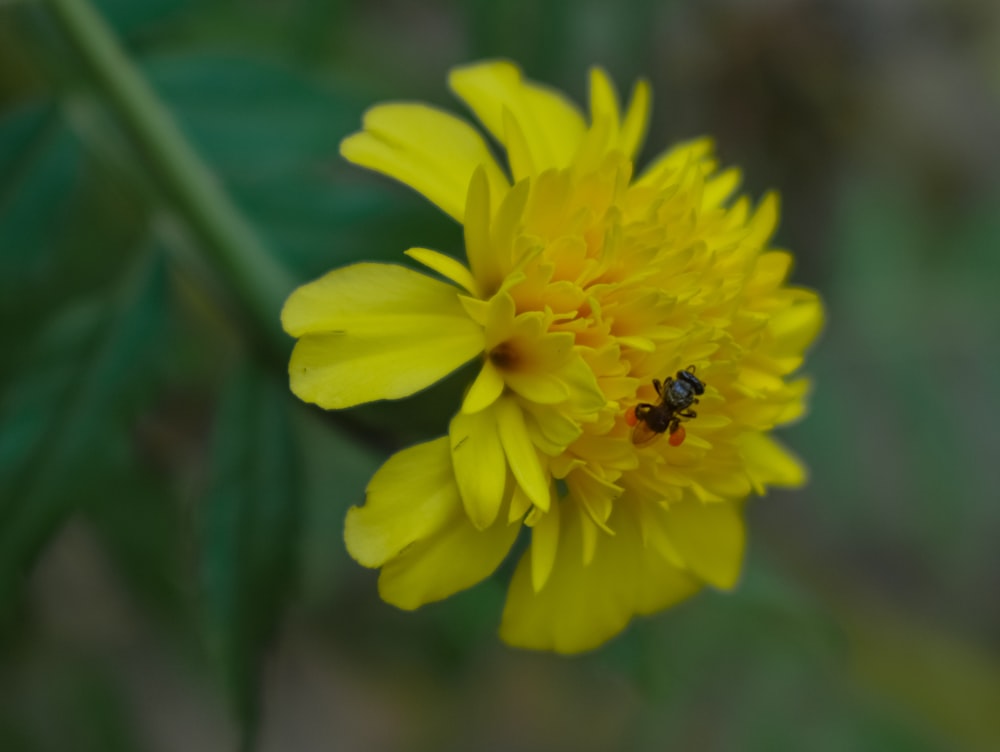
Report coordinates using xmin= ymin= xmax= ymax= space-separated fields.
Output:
xmin=340 ymin=102 xmax=507 ymax=222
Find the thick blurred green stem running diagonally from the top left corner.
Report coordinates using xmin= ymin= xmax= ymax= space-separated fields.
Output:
xmin=48 ymin=0 xmax=295 ymax=350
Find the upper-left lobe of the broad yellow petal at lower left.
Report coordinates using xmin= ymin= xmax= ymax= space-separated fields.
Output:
xmin=344 ymin=437 xmax=461 ymax=567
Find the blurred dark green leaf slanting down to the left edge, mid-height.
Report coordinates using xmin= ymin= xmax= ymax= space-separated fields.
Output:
xmin=0 ymin=254 xmax=165 ymax=604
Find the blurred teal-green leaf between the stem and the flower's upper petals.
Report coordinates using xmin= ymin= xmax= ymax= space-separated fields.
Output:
xmin=144 ymin=54 xmax=461 ymax=278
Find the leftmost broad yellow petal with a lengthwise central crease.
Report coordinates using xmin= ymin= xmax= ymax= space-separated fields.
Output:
xmin=281 ymin=264 xmax=483 ymax=409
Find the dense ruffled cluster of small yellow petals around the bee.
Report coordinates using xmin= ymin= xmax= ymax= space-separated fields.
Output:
xmin=463 ymin=141 xmax=804 ymax=533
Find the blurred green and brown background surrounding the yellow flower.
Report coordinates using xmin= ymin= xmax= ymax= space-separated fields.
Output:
xmin=0 ymin=0 xmax=1000 ymax=752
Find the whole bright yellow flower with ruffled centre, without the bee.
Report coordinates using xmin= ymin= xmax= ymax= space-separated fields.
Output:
xmin=282 ymin=62 xmax=823 ymax=653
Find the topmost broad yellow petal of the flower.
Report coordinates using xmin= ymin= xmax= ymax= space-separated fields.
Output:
xmin=448 ymin=60 xmax=586 ymax=175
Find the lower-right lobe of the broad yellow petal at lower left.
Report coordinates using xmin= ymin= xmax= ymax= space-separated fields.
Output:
xmin=378 ymin=492 xmax=520 ymax=610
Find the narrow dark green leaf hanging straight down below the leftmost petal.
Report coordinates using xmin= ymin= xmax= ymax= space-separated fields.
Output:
xmin=200 ymin=367 xmax=300 ymax=748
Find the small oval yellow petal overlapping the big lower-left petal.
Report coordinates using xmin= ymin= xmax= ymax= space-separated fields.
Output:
xmin=448 ymin=410 xmax=507 ymax=530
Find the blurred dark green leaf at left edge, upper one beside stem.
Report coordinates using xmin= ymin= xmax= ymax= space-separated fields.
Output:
xmin=0 ymin=104 xmax=154 ymax=386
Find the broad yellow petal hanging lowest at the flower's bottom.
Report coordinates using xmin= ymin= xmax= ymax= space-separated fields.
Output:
xmin=500 ymin=503 xmax=698 ymax=653
